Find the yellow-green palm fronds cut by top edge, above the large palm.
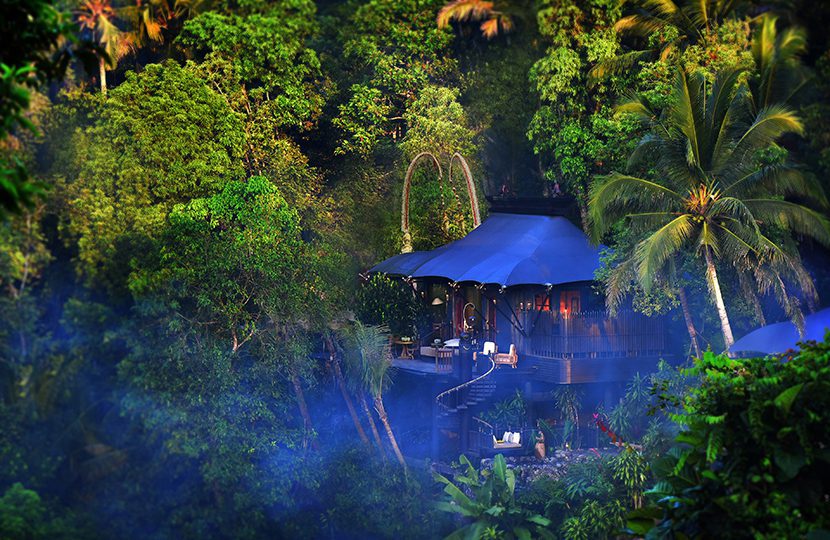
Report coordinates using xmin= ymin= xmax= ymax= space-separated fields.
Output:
xmin=590 ymin=0 xmax=743 ymax=78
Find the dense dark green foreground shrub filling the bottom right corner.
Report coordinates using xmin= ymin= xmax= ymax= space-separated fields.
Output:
xmin=629 ymin=336 xmax=830 ymax=538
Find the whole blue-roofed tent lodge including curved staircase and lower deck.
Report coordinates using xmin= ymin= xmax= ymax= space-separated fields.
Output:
xmin=370 ymin=199 xmax=666 ymax=457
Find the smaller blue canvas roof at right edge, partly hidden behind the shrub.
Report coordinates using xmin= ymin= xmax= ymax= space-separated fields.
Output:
xmin=729 ymin=308 xmax=830 ymax=354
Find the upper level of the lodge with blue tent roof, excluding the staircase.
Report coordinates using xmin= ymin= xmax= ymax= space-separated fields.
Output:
xmin=370 ymin=199 xmax=665 ymax=384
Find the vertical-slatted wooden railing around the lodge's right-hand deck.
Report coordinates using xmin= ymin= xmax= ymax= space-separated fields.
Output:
xmin=516 ymin=311 xmax=665 ymax=358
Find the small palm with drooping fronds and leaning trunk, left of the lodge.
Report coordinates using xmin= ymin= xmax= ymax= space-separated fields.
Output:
xmin=351 ymin=321 xmax=406 ymax=470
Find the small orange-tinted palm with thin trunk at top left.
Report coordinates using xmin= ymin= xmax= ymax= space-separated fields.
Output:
xmin=77 ymin=0 xmax=135 ymax=94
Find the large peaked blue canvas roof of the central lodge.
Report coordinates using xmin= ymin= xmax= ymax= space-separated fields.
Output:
xmin=370 ymin=214 xmax=602 ymax=287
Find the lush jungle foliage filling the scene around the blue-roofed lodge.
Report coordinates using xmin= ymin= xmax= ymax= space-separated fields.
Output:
xmin=0 ymin=0 xmax=830 ymax=539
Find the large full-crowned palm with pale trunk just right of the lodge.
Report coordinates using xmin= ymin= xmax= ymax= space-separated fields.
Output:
xmin=590 ymin=70 xmax=830 ymax=348
